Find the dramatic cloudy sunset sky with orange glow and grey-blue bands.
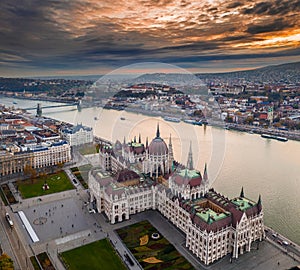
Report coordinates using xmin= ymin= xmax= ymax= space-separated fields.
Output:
xmin=0 ymin=0 xmax=300 ymax=77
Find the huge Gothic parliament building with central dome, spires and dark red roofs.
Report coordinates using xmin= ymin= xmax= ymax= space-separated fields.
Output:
xmin=89 ymin=126 xmax=265 ymax=265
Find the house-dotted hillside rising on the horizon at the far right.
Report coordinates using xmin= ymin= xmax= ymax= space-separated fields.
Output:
xmin=196 ymin=62 xmax=300 ymax=83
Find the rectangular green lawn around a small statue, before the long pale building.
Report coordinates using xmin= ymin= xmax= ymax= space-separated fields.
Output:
xmin=18 ymin=171 xmax=74 ymax=199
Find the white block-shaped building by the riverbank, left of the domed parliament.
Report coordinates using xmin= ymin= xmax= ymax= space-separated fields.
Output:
xmin=61 ymin=124 xmax=94 ymax=146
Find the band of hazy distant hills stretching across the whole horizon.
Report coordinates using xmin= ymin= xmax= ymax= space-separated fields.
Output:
xmin=0 ymin=62 xmax=300 ymax=93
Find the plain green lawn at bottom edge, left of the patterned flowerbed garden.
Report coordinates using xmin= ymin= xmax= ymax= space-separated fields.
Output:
xmin=61 ymin=239 xmax=126 ymax=270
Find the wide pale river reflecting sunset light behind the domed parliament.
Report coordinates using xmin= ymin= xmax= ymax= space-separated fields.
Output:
xmin=0 ymin=98 xmax=300 ymax=244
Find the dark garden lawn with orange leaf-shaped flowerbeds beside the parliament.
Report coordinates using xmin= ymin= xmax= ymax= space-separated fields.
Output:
xmin=117 ymin=221 xmax=194 ymax=270
